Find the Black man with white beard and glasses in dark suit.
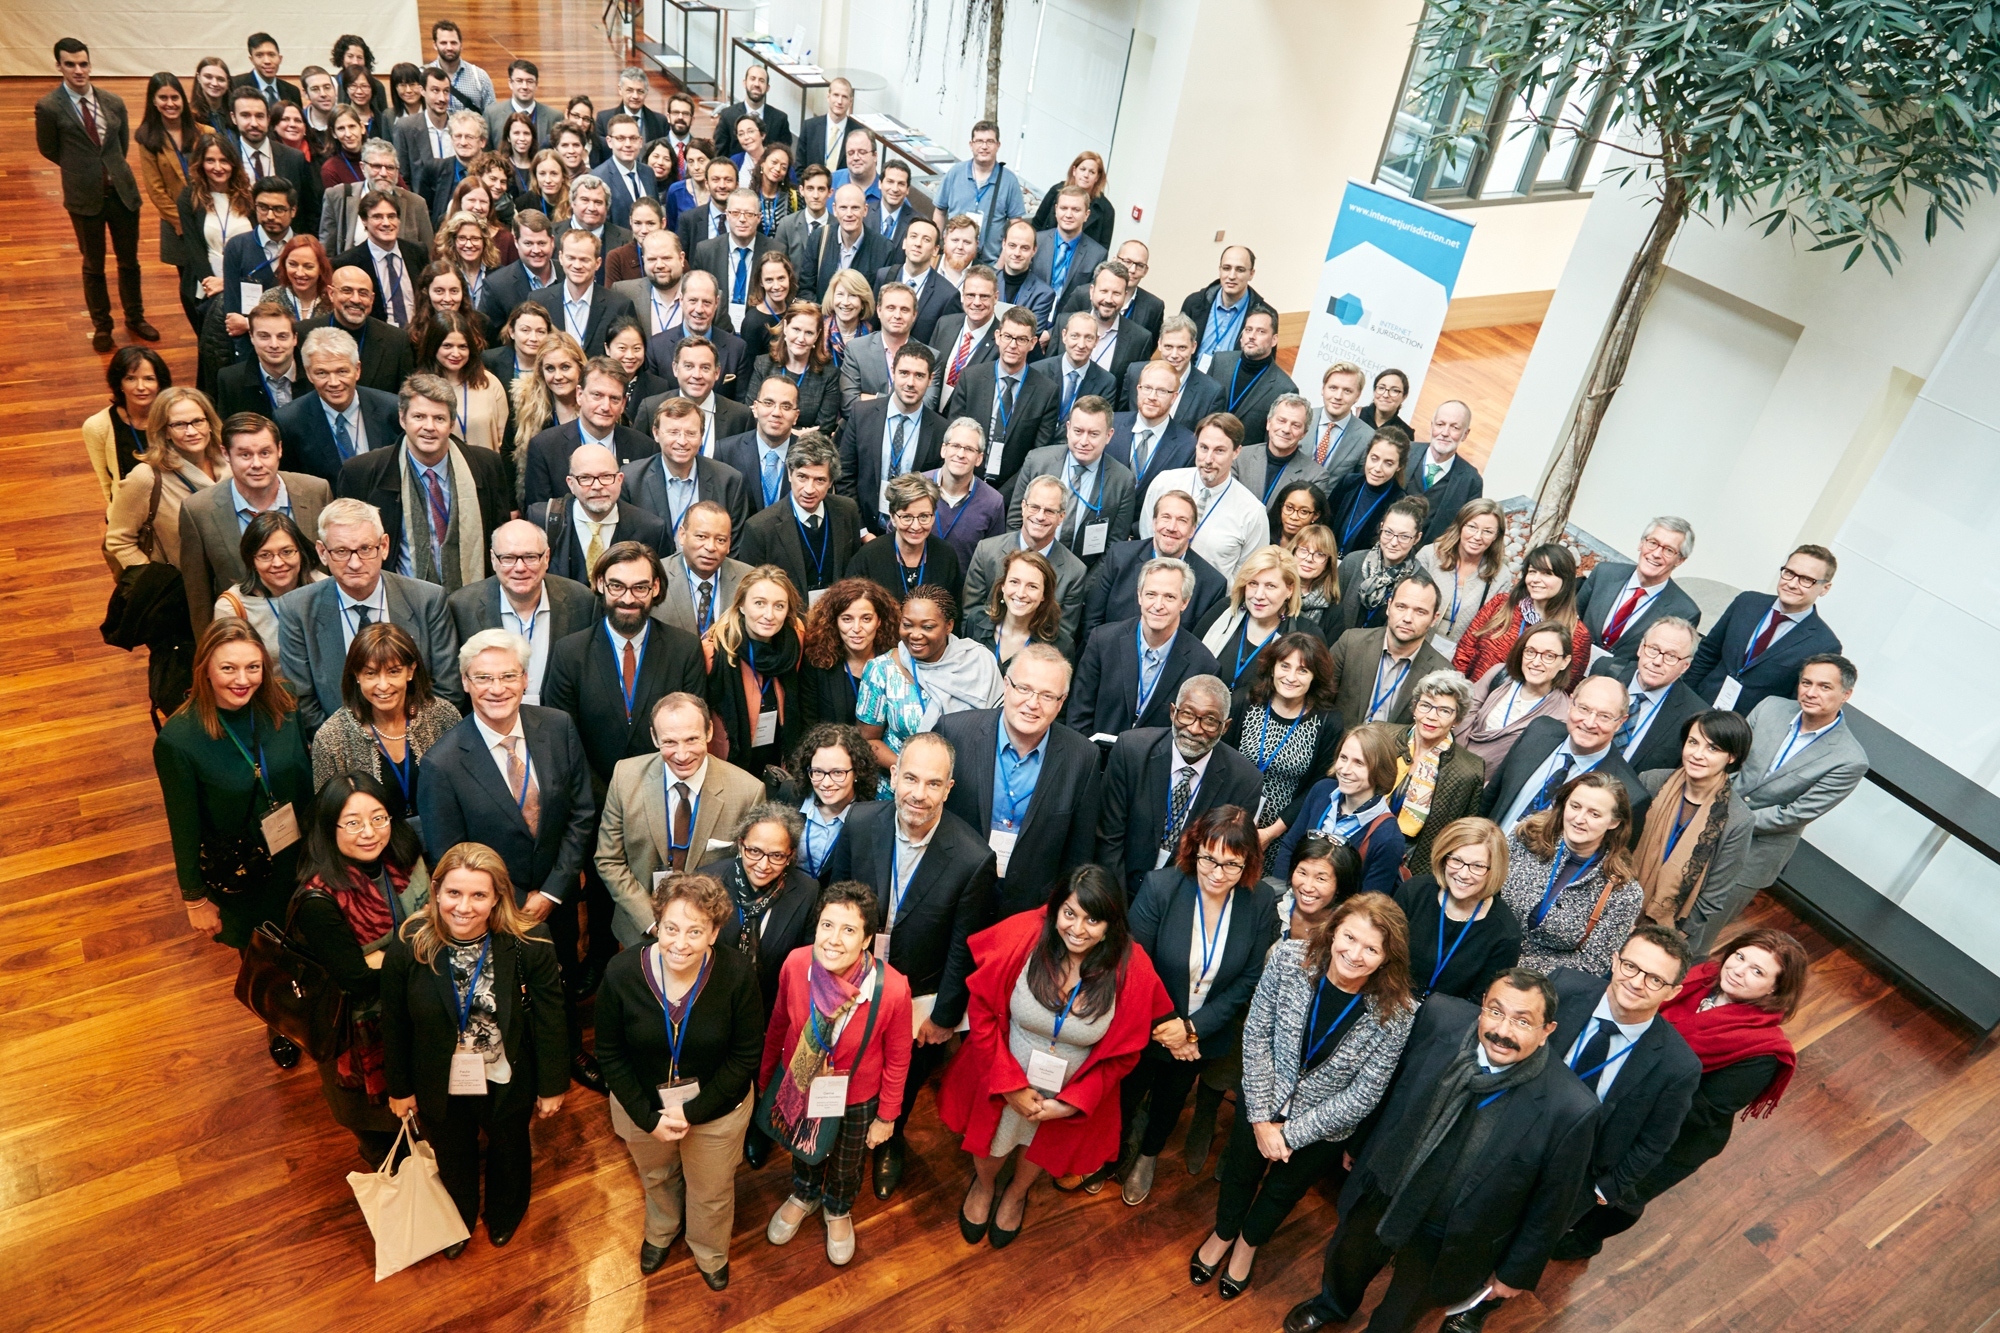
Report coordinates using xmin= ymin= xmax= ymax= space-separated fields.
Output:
xmin=1096 ymin=677 xmax=1264 ymax=903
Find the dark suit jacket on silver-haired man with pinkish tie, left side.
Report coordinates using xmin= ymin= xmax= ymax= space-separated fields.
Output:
xmin=416 ymin=700 xmax=598 ymax=896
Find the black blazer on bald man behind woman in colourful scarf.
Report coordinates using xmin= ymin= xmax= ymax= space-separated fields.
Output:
xmin=826 ymin=801 xmax=994 ymax=1029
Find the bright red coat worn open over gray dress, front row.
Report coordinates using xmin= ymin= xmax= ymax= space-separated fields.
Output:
xmin=938 ymin=907 xmax=1174 ymax=1175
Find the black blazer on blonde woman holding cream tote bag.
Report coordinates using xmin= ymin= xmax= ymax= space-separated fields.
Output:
xmin=382 ymin=924 xmax=570 ymax=1123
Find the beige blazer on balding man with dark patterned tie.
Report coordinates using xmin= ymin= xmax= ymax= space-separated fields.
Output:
xmin=596 ymin=755 xmax=764 ymax=949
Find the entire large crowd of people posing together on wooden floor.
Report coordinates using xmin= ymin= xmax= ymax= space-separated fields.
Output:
xmin=36 ymin=20 xmax=1866 ymax=1331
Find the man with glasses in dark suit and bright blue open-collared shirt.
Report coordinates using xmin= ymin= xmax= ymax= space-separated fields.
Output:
xmin=936 ymin=642 xmax=1102 ymax=917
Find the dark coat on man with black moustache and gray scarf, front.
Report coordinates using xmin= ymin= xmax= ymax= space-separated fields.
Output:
xmin=1340 ymin=995 xmax=1598 ymax=1305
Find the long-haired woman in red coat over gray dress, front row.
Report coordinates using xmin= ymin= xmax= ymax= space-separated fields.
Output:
xmin=938 ymin=865 xmax=1174 ymax=1249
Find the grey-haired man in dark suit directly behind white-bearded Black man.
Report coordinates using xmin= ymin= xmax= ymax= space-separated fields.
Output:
xmin=1066 ymin=558 xmax=1216 ymax=739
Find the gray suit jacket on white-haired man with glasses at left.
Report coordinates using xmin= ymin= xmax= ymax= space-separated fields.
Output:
xmin=278 ymin=570 xmax=466 ymax=733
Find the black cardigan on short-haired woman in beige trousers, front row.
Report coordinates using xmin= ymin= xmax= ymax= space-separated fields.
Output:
xmin=596 ymin=932 xmax=764 ymax=1133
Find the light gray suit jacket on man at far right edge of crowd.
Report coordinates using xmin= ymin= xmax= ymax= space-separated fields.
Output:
xmin=1736 ymin=697 xmax=1868 ymax=899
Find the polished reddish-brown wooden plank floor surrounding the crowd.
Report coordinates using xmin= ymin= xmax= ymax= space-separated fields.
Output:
xmin=0 ymin=2 xmax=2000 ymax=1333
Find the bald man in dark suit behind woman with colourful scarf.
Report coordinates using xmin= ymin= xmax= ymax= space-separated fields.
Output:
xmin=828 ymin=736 xmax=996 ymax=1199
